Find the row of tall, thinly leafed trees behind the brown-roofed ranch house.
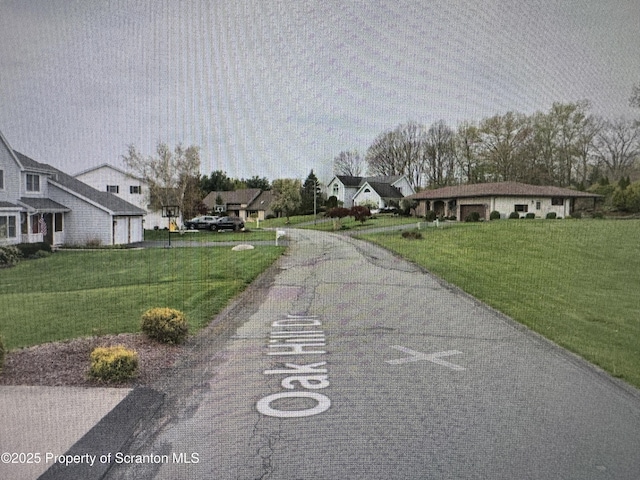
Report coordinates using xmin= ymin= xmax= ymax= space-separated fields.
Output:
xmin=334 ymin=97 xmax=640 ymax=189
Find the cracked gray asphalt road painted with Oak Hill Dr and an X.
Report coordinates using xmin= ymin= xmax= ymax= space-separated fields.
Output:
xmin=106 ymin=230 xmax=640 ymax=480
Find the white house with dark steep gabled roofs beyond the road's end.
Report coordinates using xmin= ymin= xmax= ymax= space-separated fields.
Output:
xmin=327 ymin=175 xmax=415 ymax=208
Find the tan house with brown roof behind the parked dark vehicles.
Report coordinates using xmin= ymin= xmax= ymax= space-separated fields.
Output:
xmin=202 ymin=188 xmax=273 ymax=220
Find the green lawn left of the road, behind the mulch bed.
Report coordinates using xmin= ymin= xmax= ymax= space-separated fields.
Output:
xmin=0 ymin=247 xmax=284 ymax=349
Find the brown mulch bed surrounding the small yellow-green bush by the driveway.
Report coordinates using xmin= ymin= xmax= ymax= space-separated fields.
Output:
xmin=0 ymin=333 xmax=183 ymax=387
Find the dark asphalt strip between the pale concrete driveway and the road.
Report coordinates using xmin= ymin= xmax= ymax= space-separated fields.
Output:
xmin=38 ymin=387 xmax=164 ymax=480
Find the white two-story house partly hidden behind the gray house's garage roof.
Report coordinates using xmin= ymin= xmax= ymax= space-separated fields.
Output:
xmin=75 ymin=163 xmax=168 ymax=229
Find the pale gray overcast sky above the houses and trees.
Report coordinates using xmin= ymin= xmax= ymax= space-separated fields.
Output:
xmin=0 ymin=0 xmax=640 ymax=181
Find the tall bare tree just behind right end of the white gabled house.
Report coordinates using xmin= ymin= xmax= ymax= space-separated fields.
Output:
xmin=366 ymin=122 xmax=426 ymax=188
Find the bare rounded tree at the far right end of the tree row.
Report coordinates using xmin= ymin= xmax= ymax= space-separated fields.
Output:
xmin=594 ymin=118 xmax=640 ymax=180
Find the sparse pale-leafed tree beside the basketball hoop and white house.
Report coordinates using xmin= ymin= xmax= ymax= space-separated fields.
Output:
xmin=122 ymin=142 xmax=201 ymax=217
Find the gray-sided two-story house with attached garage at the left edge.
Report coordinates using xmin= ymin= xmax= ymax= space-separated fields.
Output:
xmin=0 ymin=132 xmax=146 ymax=245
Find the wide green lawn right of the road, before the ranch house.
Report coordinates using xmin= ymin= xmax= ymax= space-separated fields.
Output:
xmin=362 ymin=220 xmax=640 ymax=387
